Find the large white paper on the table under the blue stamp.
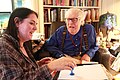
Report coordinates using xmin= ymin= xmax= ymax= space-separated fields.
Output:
xmin=58 ymin=64 xmax=108 ymax=80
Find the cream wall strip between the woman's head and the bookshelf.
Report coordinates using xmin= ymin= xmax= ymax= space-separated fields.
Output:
xmin=23 ymin=0 xmax=44 ymax=34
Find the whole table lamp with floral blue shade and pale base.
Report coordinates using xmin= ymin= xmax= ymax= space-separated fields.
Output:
xmin=99 ymin=12 xmax=117 ymax=47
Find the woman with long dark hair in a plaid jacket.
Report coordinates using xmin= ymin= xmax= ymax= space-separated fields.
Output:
xmin=0 ymin=8 xmax=76 ymax=80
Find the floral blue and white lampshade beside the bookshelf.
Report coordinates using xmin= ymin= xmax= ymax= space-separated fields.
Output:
xmin=99 ymin=12 xmax=117 ymax=37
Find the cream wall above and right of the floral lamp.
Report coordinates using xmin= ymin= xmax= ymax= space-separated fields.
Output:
xmin=101 ymin=0 xmax=120 ymax=28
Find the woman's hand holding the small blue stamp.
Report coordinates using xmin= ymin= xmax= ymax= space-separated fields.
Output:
xmin=47 ymin=57 xmax=77 ymax=71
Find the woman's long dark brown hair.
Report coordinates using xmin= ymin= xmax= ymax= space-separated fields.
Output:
xmin=5 ymin=7 xmax=38 ymax=41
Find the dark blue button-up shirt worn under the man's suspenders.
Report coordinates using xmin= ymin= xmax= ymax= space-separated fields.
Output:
xmin=45 ymin=24 xmax=98 ymax=59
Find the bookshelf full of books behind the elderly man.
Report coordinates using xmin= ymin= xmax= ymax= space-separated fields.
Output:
xmin=40 ymin=0 xmax=101 ymax=39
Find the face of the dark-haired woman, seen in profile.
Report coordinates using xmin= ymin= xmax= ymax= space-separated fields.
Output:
xmin=17 ymin=14 xmax=37 ymax=42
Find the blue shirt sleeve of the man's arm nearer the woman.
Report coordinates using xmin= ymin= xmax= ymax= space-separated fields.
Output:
xmin=45 ymin=28 xmax=64 ymax=58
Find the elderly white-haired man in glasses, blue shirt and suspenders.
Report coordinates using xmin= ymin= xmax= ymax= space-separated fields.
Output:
xmin=45 ymin=8 xmax=98 ymax=62
